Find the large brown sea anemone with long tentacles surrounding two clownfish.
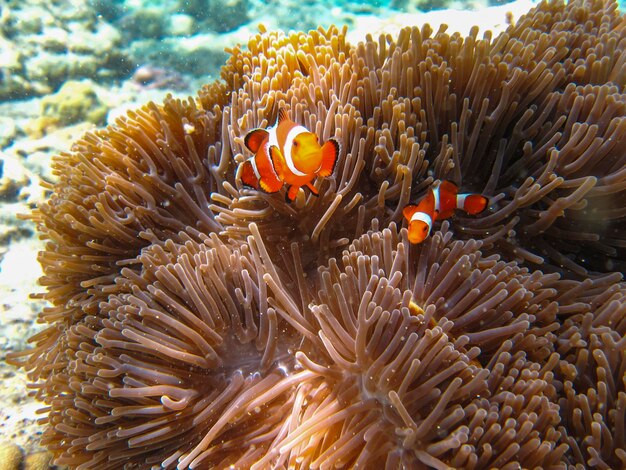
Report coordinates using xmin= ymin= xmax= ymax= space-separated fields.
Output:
xmin=11 ymin=0 xmax=626 ymax=469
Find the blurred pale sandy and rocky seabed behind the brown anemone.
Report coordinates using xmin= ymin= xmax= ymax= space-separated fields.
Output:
xmin=0 ymin=0 xmax=622 ymax=470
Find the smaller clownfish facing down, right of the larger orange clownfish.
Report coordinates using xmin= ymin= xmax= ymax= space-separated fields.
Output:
xmin=402 ymin=181 xmax=488 ymax=243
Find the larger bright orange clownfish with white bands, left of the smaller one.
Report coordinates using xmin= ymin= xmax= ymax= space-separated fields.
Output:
xmin=240 ymin=108 xmax=341 ymax=202
